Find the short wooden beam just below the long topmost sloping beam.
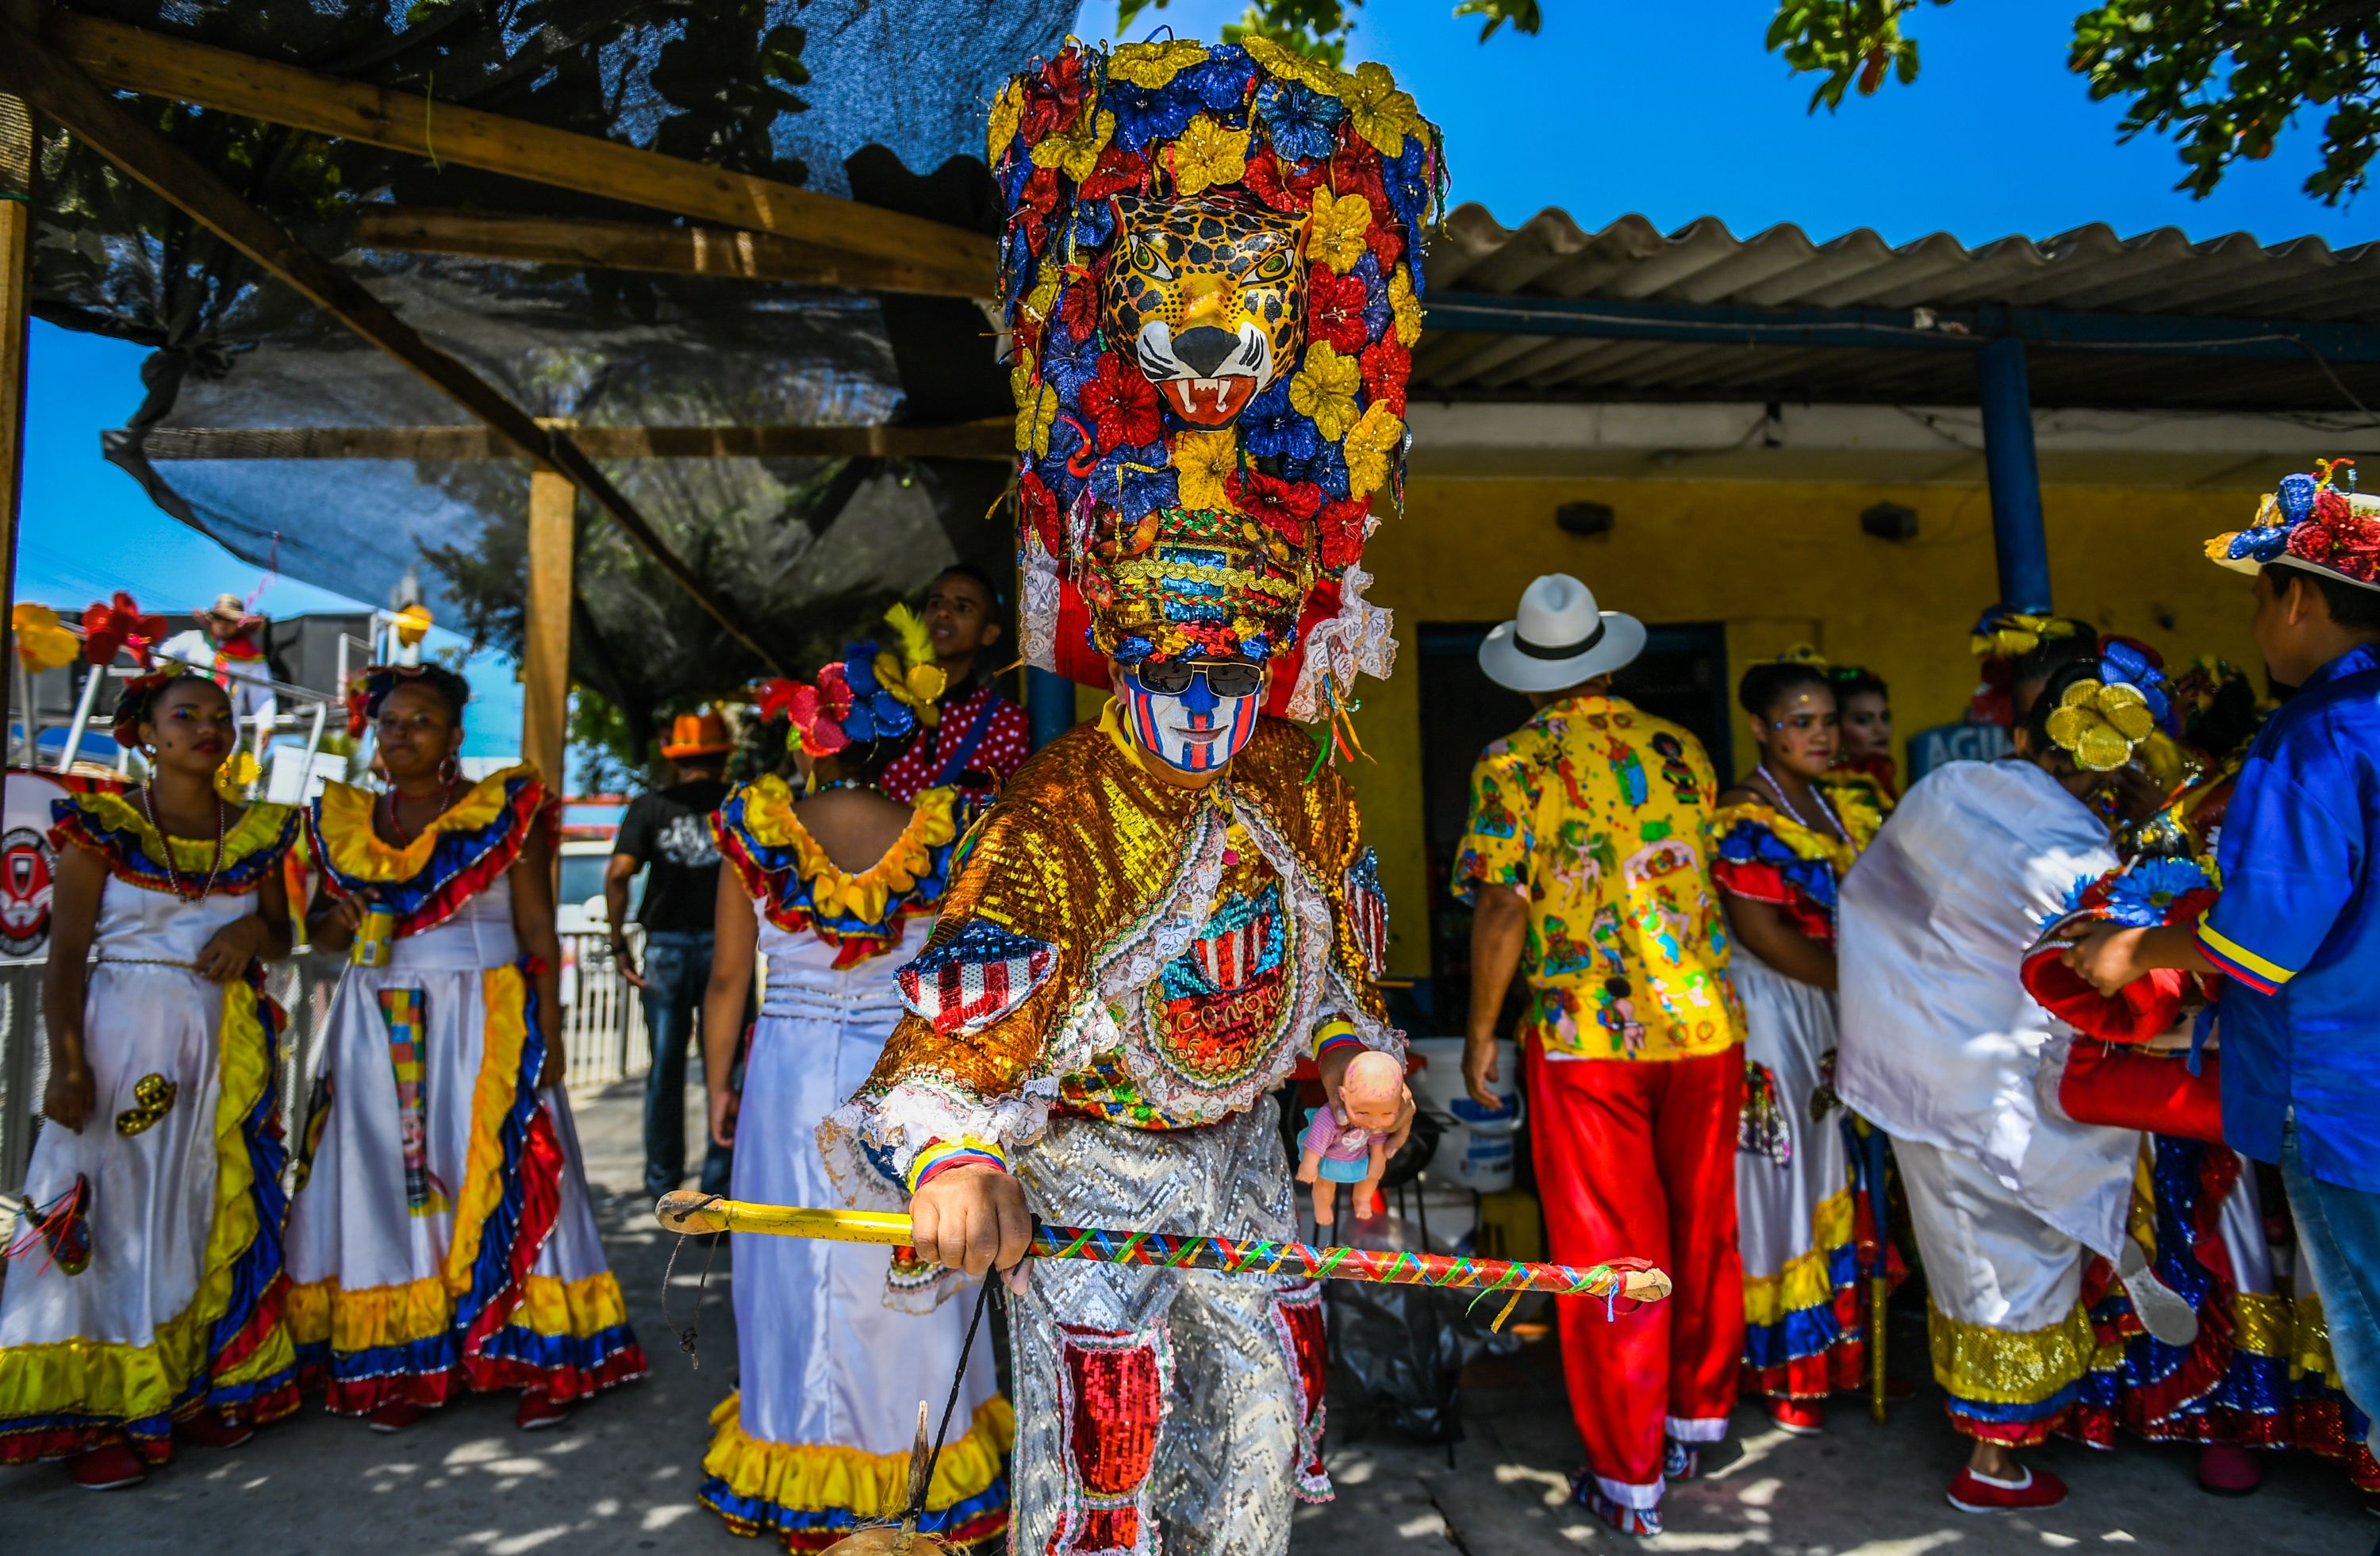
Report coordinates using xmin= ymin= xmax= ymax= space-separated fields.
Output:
xmin=355 ymin=205 xmax=985 ymax=298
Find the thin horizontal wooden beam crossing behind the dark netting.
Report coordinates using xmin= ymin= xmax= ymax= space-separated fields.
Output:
xmin=140 ymin=421 xmax=1014 ymax=462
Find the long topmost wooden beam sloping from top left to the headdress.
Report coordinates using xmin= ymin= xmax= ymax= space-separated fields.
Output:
xmin=43 ymin=10 xmax=997 ymax=298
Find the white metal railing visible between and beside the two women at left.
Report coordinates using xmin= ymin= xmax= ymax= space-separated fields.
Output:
xmin=0 ymin=935 xmax=650 ymax=1199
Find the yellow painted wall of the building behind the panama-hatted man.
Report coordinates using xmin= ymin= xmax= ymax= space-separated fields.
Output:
xmin=1349 ymin=478 xmax=2254 ymax=975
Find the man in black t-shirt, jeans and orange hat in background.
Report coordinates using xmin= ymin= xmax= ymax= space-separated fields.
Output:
xmin=602 ymin=714 xmax=735 ymax=1194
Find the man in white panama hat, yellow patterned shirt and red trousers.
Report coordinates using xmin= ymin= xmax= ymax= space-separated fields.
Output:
xmin=1454 ymin=574 xmax=1745 ymax=1535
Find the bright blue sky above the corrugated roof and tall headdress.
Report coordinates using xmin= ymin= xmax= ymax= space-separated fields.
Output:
xmin=1076 ymin=0 xmax=2380 ymax=245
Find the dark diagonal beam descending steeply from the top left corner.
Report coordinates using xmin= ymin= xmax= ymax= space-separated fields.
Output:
xmin=0 ymin=21 xmax=783 ymax=674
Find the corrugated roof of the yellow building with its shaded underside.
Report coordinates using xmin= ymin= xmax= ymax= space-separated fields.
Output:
xmin=1411 ymin=205 xmax=2380 ymax=414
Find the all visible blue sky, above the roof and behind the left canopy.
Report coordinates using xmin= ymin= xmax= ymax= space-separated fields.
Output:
xmin=17 ymin=0 xmax=2380 ymax=761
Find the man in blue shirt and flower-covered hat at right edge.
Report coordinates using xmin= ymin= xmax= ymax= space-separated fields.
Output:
xmin=2066 ymin=469 xmax=2380 ymax=1475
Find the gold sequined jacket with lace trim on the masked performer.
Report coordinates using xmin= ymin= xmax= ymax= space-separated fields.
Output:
xmin=819 ymin=717 xmax=1404 ymax=1199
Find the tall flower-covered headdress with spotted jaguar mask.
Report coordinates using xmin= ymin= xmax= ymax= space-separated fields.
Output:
xmin=990 ymin=38 xmax=1445 ymax=719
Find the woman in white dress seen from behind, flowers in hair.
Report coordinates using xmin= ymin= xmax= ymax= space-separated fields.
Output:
xmin=700 ymin=633 xmax=1014 ymax=1554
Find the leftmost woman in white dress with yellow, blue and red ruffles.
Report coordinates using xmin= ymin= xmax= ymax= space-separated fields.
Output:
xmin=0 ymin=674 xmax=298 ymax=1489
